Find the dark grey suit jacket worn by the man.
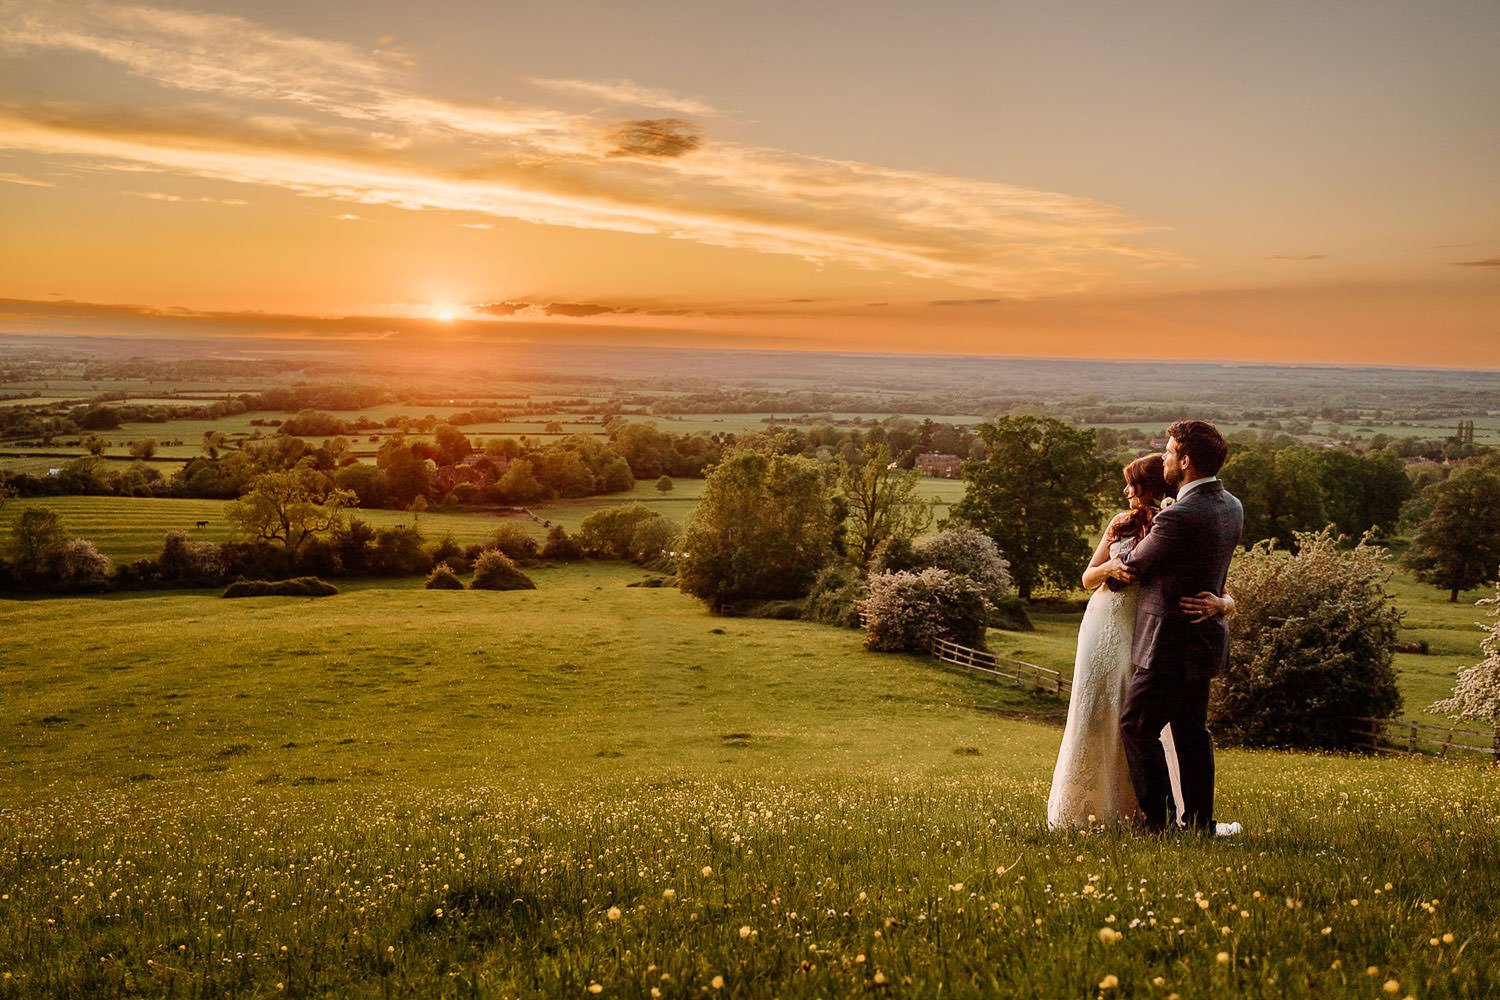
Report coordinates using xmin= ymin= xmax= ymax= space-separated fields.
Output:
xmin=1124 ymin=480 xmax=1245 ymax=679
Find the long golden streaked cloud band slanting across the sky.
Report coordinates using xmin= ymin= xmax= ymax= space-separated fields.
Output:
xmin=0 ymin=0 xmax=1185 ymax=298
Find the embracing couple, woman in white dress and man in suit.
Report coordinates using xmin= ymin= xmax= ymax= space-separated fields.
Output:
xmin=1047 ymin=420 xmax=1244 ymax=837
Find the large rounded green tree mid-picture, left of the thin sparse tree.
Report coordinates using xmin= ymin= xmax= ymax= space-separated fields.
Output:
xmin=678 ymin=450 xmax=834 ymax=612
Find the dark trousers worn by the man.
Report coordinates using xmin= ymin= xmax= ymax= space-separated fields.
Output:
xmin=1121 ymin=667 xmax=1214 ymax=829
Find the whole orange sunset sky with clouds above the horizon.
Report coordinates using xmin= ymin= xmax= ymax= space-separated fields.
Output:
xmin=0 ymin=0 xmax=1500 ymax=367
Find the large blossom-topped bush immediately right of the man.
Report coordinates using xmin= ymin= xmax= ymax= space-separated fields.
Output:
xmin=1209 ymin=529 xmax=1401 ymax=750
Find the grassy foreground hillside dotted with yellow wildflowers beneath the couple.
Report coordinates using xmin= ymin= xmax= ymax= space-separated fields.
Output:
xmin=0 ymin=564 xmax=1500 ymax=997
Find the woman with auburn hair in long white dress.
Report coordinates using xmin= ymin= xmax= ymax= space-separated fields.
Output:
xmin=1047 ymin=454 xmax=1235 ymax=829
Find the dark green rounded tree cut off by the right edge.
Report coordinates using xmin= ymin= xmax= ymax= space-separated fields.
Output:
xmin=1404 ymin=465 xmax=1500 ymax=603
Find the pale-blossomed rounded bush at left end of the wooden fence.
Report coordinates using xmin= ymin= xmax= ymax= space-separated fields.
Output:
xmin=860 ymin=568 xmax=989 ymax=652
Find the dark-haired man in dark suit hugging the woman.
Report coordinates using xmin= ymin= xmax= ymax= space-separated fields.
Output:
xmin=1121 ymin=420 xmax=1245 ymax=834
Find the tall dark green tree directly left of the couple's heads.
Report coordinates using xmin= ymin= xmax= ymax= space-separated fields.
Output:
xmin=953 ymin=415 xmax=1112 ymax=600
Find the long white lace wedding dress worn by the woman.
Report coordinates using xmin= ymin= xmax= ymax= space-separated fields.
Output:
xmin=1047 ymin=540 xmax=1182 ymax=829
